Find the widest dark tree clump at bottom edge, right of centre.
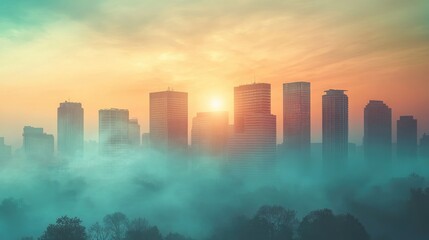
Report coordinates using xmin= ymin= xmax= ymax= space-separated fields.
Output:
xmin=298 ymin=209 xmax=370 ymax=240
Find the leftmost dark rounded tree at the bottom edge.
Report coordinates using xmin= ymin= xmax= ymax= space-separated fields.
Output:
xmin=39 ymin=216 xmax=87 ymax=240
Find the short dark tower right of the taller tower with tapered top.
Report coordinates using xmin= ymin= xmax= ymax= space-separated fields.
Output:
xmin=397 ymin=116 xmax=417 ymax=159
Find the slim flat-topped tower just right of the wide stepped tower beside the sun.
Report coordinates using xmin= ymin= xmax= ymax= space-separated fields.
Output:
xmin=283 ymin=82 xmax=311 ymax=154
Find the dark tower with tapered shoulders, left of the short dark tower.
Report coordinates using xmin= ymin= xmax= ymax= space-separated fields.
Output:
xmin=363 ymin=100 xmax=392 ymax=163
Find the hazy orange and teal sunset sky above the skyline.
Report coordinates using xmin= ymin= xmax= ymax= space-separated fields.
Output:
xmin=0 ymin=0 xmax=429 ymax=148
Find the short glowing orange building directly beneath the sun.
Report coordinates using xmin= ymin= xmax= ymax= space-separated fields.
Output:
xmin=191 ymin=112 xmax=228 ymax=156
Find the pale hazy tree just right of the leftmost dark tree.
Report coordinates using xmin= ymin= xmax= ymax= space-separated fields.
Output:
xmin=103 ymin=212 xmax=129 ymax=240
